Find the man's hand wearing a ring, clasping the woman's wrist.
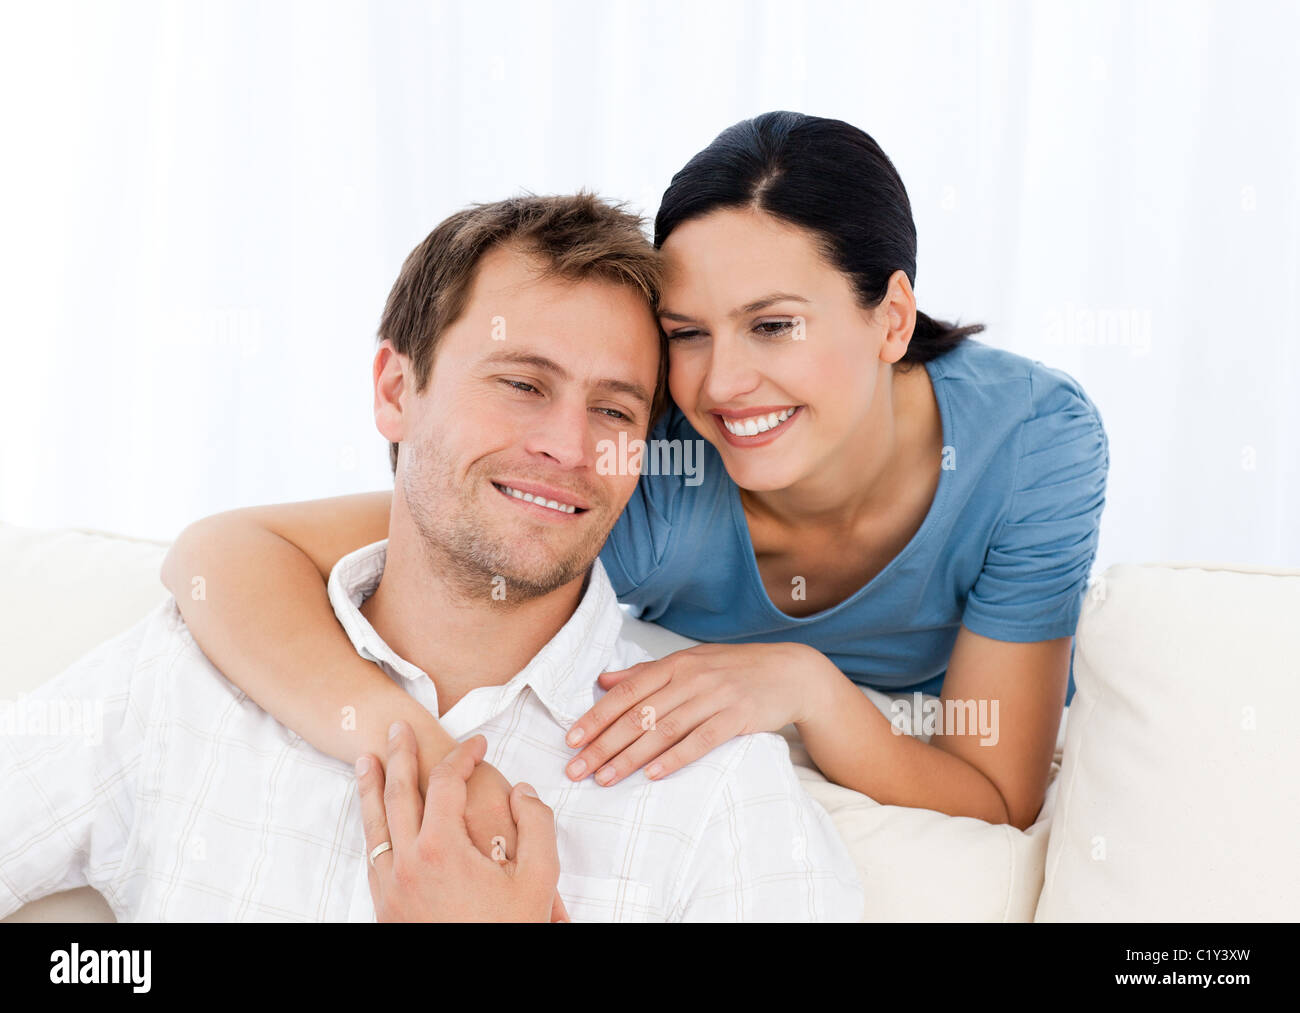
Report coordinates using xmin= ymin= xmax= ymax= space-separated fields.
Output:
xmin=358 ymin=722 xmax=574 ymax=922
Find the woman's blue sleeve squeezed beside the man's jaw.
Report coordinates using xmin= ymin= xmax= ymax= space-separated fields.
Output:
xmin=601 ymin=406 xmax=685 ymax=606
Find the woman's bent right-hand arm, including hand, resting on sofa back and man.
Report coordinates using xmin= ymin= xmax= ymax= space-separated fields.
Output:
xmin=567 ymin=637 xmax=1070 ymax=830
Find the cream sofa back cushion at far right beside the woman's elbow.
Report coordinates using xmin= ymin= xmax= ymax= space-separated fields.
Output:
xmin=1035 ymin=564 xmax=1300 ymax=922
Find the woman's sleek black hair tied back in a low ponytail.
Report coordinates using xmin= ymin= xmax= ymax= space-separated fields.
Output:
xmin=654 ymin=112 xmax=984 ymax=364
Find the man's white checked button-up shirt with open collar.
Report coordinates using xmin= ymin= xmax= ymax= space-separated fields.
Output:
xmin=0 ymin=542 xmax=863 ymax=922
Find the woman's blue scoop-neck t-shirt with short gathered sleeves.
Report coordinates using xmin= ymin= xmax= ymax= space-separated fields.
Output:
xmin=601 ymin=338 xmax=1110 ymax=704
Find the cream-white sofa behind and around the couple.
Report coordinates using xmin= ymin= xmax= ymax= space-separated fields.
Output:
xmin=0 ymin=524 xmax=1300 ymax=922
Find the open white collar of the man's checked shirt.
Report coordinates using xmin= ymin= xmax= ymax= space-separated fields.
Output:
xmin=329 ymin=540 xmax=623 ymax=737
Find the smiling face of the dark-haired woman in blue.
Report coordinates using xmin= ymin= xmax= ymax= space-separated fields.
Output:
xmin=659 ymin=208 xmax=906 ymax=492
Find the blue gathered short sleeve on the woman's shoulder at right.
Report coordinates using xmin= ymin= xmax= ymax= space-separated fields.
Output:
xmin=962 ymin=363 xmax=1110 ymax=644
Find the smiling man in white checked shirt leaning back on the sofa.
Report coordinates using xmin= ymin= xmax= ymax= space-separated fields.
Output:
xmin=0 ymin=195 xmax=863 ymax=921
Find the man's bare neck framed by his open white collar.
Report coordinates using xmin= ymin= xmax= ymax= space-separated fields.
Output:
xmin=360 ymin=518 xmax=585 ymax=718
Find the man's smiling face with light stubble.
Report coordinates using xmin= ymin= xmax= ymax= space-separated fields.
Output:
xmin=386 ymin=247 xmax=659 ymax=602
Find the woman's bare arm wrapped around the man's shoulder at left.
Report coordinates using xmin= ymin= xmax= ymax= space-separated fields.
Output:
xmin=161 ymin=493 xmax=456 ymax=784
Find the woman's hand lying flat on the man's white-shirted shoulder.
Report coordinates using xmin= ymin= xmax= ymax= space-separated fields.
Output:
xmin=566 ymin=644 xmax=839 ymax=785
